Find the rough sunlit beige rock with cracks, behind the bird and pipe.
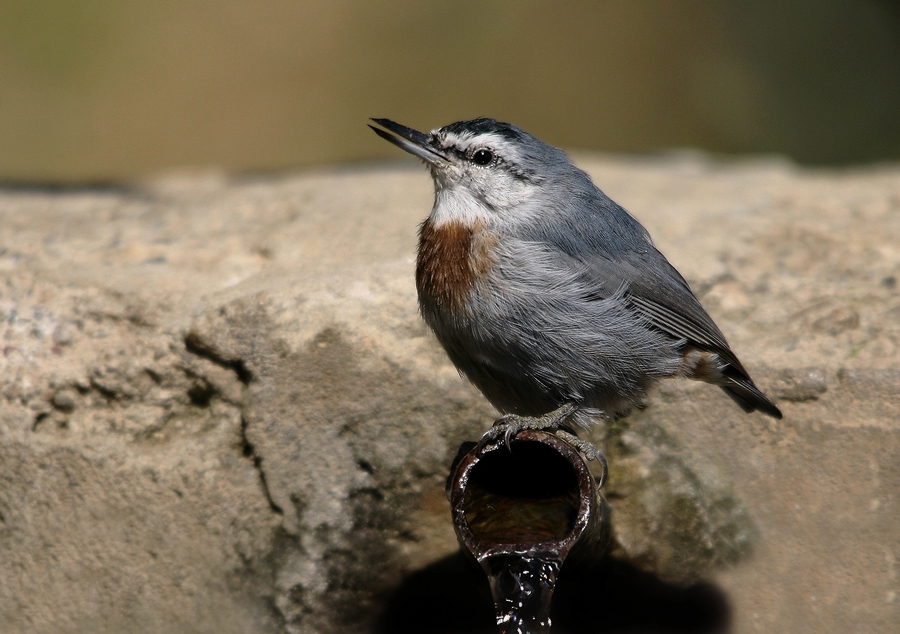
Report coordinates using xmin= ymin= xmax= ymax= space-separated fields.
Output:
xmin=0 ymin=155 xmax=900 ymax=634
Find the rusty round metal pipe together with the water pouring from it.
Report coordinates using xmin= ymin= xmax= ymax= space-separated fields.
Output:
xmin=448 ymin=430 xmax=609 ymax=634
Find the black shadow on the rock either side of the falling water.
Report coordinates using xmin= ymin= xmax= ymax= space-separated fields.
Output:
xmin=376 ymin=552 xmax=730 ymax=634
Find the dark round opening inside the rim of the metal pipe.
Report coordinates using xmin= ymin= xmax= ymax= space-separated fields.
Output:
xmin=462 ymin=441 xmax=581 ymax=544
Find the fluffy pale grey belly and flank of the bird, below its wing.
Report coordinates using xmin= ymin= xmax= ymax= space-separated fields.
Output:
xmin=419 ymin=232 xmax=683 ymax=415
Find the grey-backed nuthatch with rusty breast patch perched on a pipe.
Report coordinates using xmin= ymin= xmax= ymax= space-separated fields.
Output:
xmin=369 ymin=119 xmax=781 ymax=439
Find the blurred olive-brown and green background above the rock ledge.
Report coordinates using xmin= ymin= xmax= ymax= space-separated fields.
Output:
xmin=0 ymin=0 xmax=900 ymax=182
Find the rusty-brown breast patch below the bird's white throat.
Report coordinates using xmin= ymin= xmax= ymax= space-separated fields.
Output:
xmin=416 ymin=219 xmax=497 ymax=312
